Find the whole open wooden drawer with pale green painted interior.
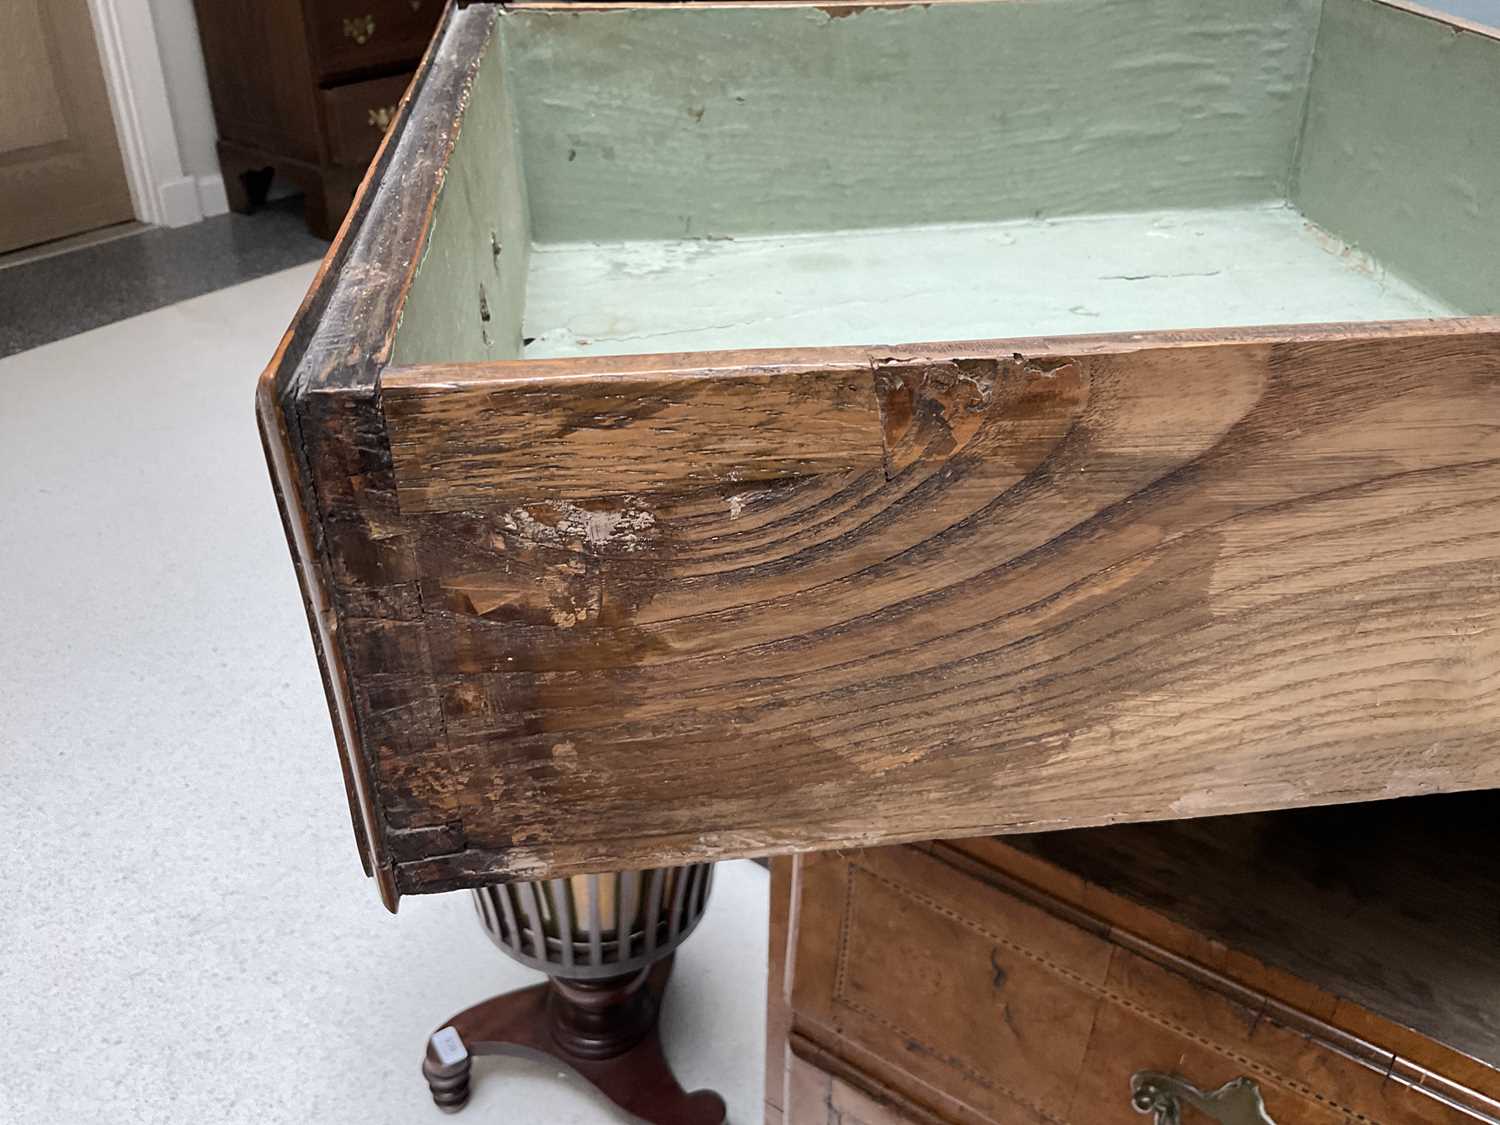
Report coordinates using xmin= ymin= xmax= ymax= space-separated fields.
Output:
xmin=260 ymin=0 xmax=1500 ymax=905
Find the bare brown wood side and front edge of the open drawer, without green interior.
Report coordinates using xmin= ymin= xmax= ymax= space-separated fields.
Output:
xmin=261 ymin=6 xmax=1500 ymax=903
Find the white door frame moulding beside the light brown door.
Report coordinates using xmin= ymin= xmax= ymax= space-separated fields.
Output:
xmin=89 ymin=0 xmax=230 ymax=227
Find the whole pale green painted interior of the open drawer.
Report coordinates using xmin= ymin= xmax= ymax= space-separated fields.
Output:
xmin=398 ymin=0 xmax=1500 ymax=363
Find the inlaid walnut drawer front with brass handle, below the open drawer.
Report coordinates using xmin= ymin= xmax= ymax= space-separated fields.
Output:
xmin=792 ymin=848 xmax=1493 ymax=1125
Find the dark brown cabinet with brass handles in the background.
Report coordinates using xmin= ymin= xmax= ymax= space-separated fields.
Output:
xmin=195 ymin=0 xmax=444 ymax=239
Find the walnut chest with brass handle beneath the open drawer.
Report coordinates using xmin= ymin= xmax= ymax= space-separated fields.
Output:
xmin=767 ymin=794 xmax=1500 ymax=1125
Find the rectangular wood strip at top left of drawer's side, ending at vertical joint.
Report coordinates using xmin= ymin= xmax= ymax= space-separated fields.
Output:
xmin=383 ymin=363 xmax=884 ymax=513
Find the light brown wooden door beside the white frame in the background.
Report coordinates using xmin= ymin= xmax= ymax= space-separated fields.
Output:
xmin=0 ymin=0 xmax=134 ymax=252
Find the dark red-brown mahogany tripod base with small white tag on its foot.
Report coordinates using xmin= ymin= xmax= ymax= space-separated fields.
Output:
xmin=422 ymin=957 xmax=725 ymax=1125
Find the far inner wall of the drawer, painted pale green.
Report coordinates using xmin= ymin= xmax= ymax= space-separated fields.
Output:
xmin=501 ymin=0 xmax=1317 ymax=242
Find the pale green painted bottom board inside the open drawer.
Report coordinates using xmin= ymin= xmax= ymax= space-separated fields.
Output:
xmin=525 ymin=204 xmax=1454 ymax=359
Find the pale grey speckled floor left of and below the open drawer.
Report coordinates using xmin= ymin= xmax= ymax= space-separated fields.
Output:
xmin=0 ymin=264 xmax=767 ymax=1125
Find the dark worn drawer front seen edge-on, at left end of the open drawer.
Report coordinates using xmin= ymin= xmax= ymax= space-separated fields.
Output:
xmin=255 ymin=9 xmax=494 ymax=911
